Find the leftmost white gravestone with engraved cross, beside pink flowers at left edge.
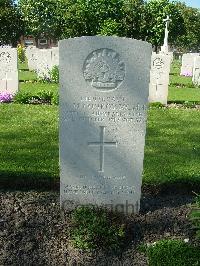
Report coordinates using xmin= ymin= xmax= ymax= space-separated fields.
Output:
xmin=0 ymin=47 xmax=19 ymax=94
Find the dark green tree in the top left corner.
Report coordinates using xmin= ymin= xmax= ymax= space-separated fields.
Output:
xmin=0 ymin=0 xmax=24 ymax=46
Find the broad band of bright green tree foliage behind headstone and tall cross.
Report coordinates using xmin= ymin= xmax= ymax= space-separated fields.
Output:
xmin=18 ymin=0 xmax=200 ymax=50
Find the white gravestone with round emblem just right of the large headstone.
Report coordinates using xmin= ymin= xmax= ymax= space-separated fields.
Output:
xmin=149 ymin=54 xmax=171 ymax=104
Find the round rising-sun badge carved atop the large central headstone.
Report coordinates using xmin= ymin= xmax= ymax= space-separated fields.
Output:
xmin=83 ymin=48 xmax=125 ymax=91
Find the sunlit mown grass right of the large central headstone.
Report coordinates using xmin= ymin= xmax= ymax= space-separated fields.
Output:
xmin=144 ymin=108 xmax=200 ymax=188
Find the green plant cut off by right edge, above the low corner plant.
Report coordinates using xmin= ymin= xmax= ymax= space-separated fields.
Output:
xmin=189 ymin=194 xmax=200 ymax=239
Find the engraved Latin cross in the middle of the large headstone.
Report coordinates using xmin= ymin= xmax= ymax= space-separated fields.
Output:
xmin=88 ymin=126 xmax=117 ymax=172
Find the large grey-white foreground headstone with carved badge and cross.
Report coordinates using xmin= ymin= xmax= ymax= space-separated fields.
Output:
xmin=59 ymin=36 xmax=152 ymax=213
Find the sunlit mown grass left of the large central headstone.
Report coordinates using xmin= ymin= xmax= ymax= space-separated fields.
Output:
xmin=0 ymin=104 xmax=59 ymax=188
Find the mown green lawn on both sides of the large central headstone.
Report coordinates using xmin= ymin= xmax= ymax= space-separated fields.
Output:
xmin=0 ymin=104 xmax=200 ymax=190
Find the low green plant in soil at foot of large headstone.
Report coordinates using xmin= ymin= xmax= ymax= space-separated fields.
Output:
xmin=70 ymin=207 xmax=125 ymax=250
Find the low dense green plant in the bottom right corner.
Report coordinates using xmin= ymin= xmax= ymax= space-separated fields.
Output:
xmin=142 ymin=240 xmax=200 ymax=266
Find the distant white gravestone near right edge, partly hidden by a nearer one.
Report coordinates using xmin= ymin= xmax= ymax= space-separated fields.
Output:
xmin=180 ymin=53 xmax=199 ymax=77
